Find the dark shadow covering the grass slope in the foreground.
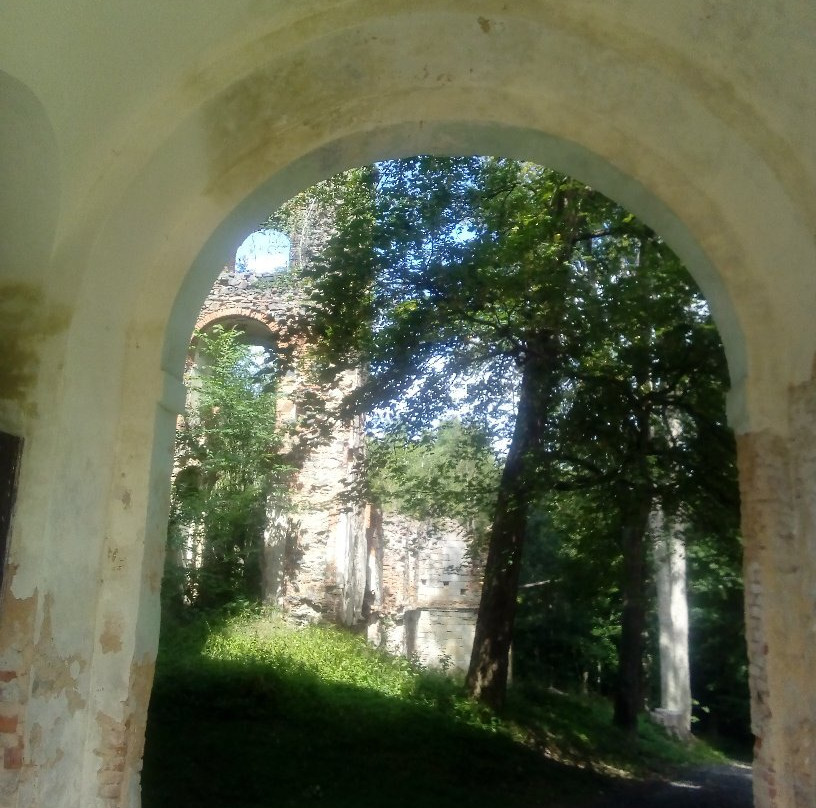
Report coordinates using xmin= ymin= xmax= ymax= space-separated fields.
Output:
xmin=142 ymin=658 xmax=606 ymax=808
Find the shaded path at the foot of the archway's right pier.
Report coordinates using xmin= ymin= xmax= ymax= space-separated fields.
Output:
xmin=590 ymin=763 xmax=754 ymax=808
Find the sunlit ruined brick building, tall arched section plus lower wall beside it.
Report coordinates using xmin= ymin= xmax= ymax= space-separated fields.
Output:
xmin=190 ymin=262 xmax=480 ymax=670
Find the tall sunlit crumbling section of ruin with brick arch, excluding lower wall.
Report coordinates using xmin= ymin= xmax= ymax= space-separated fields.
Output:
xmin=197 ymin=268 xmax=368 ymax=626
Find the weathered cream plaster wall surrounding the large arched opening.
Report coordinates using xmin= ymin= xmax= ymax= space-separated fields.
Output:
xmin=0 ymin=0 xmax=816 ymax=808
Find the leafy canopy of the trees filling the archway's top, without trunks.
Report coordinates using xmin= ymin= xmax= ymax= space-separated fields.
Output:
xmin=290 ymin=157 xmax=735 ymax=512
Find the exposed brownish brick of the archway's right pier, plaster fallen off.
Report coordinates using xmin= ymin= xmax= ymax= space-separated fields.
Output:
xmin=737 ymin=382 xmax=816 ymax=808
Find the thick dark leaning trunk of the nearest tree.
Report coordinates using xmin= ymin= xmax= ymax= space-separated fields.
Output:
xmin=466 ymin=337 xmax=555 ymax=710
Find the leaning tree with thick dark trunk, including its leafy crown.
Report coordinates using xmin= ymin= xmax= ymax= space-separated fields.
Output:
xmin=298 ymin=158 xmax=614 ymax=706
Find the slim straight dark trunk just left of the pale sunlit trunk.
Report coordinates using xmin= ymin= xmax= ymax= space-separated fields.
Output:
xmin=613 ymin=489 xmax=651 ymax=734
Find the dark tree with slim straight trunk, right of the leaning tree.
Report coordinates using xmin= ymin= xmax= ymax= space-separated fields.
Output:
xmin=540 ymin=233 xmax=736 ymax=731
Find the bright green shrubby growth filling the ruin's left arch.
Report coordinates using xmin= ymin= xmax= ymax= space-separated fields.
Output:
xmin=163 ymin=326 xmax=286 ymax=608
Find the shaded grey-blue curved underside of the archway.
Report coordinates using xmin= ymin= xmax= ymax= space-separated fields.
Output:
xmin=162 ymin=122 xmax=748 ymax=400
